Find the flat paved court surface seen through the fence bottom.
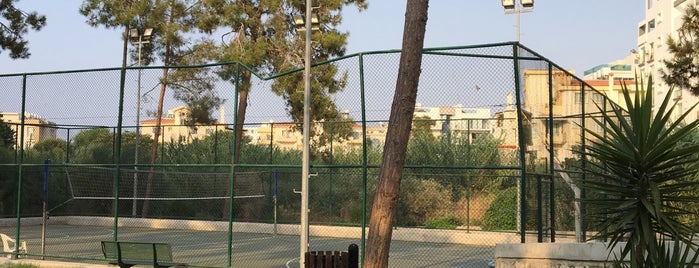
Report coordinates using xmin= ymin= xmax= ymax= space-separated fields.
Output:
xmin=0 ymin=220 xmax=494 ymax=268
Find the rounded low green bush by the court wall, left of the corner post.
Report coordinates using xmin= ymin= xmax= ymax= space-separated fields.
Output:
xmin=481 ymin=187 xmax=517 ymax=231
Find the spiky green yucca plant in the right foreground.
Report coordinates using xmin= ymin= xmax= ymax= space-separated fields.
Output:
xmin=577 ymin=77 xmax=699 ymax=267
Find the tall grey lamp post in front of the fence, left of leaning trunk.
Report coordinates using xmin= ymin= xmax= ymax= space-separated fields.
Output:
xmin=294 ymin=0 xmax=319 ymax=267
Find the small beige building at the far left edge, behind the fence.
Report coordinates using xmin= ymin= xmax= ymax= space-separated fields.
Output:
xmin=0 ymin=112 xmax=56 ymax=149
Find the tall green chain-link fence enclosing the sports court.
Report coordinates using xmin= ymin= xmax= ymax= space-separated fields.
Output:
xmin=0 ymin=43 xmax=616 ymax=267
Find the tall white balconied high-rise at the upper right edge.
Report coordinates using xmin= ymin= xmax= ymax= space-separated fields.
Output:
xmin=634 ymin=0 xmax=699 ymax=120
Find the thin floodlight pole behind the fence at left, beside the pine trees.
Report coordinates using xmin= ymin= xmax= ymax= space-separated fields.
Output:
xmin=129 ymin=28 xmax=153 ymax=216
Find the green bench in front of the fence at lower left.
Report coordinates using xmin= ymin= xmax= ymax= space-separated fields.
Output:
xmin=102 ymin=241 xmax=187 ymax=268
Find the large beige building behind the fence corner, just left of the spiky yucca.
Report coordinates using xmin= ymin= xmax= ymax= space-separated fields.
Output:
xmin=494 ymin=70 xmax=635 ymax=161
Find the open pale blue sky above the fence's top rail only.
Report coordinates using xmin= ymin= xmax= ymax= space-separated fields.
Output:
xmin=0 ymin=0 xmax=644 ymax=74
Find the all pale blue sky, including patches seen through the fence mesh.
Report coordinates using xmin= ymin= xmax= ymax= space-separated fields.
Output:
xmin=0 ymin=0 xmax=645 ymax=126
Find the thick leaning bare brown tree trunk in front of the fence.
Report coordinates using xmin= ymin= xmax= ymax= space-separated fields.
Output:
xmin=364 ymin=0 xmax=429 ymax=268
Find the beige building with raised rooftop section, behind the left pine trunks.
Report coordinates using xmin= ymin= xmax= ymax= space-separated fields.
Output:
xmin=140 ymin=106 xmax=227 ymax=142
